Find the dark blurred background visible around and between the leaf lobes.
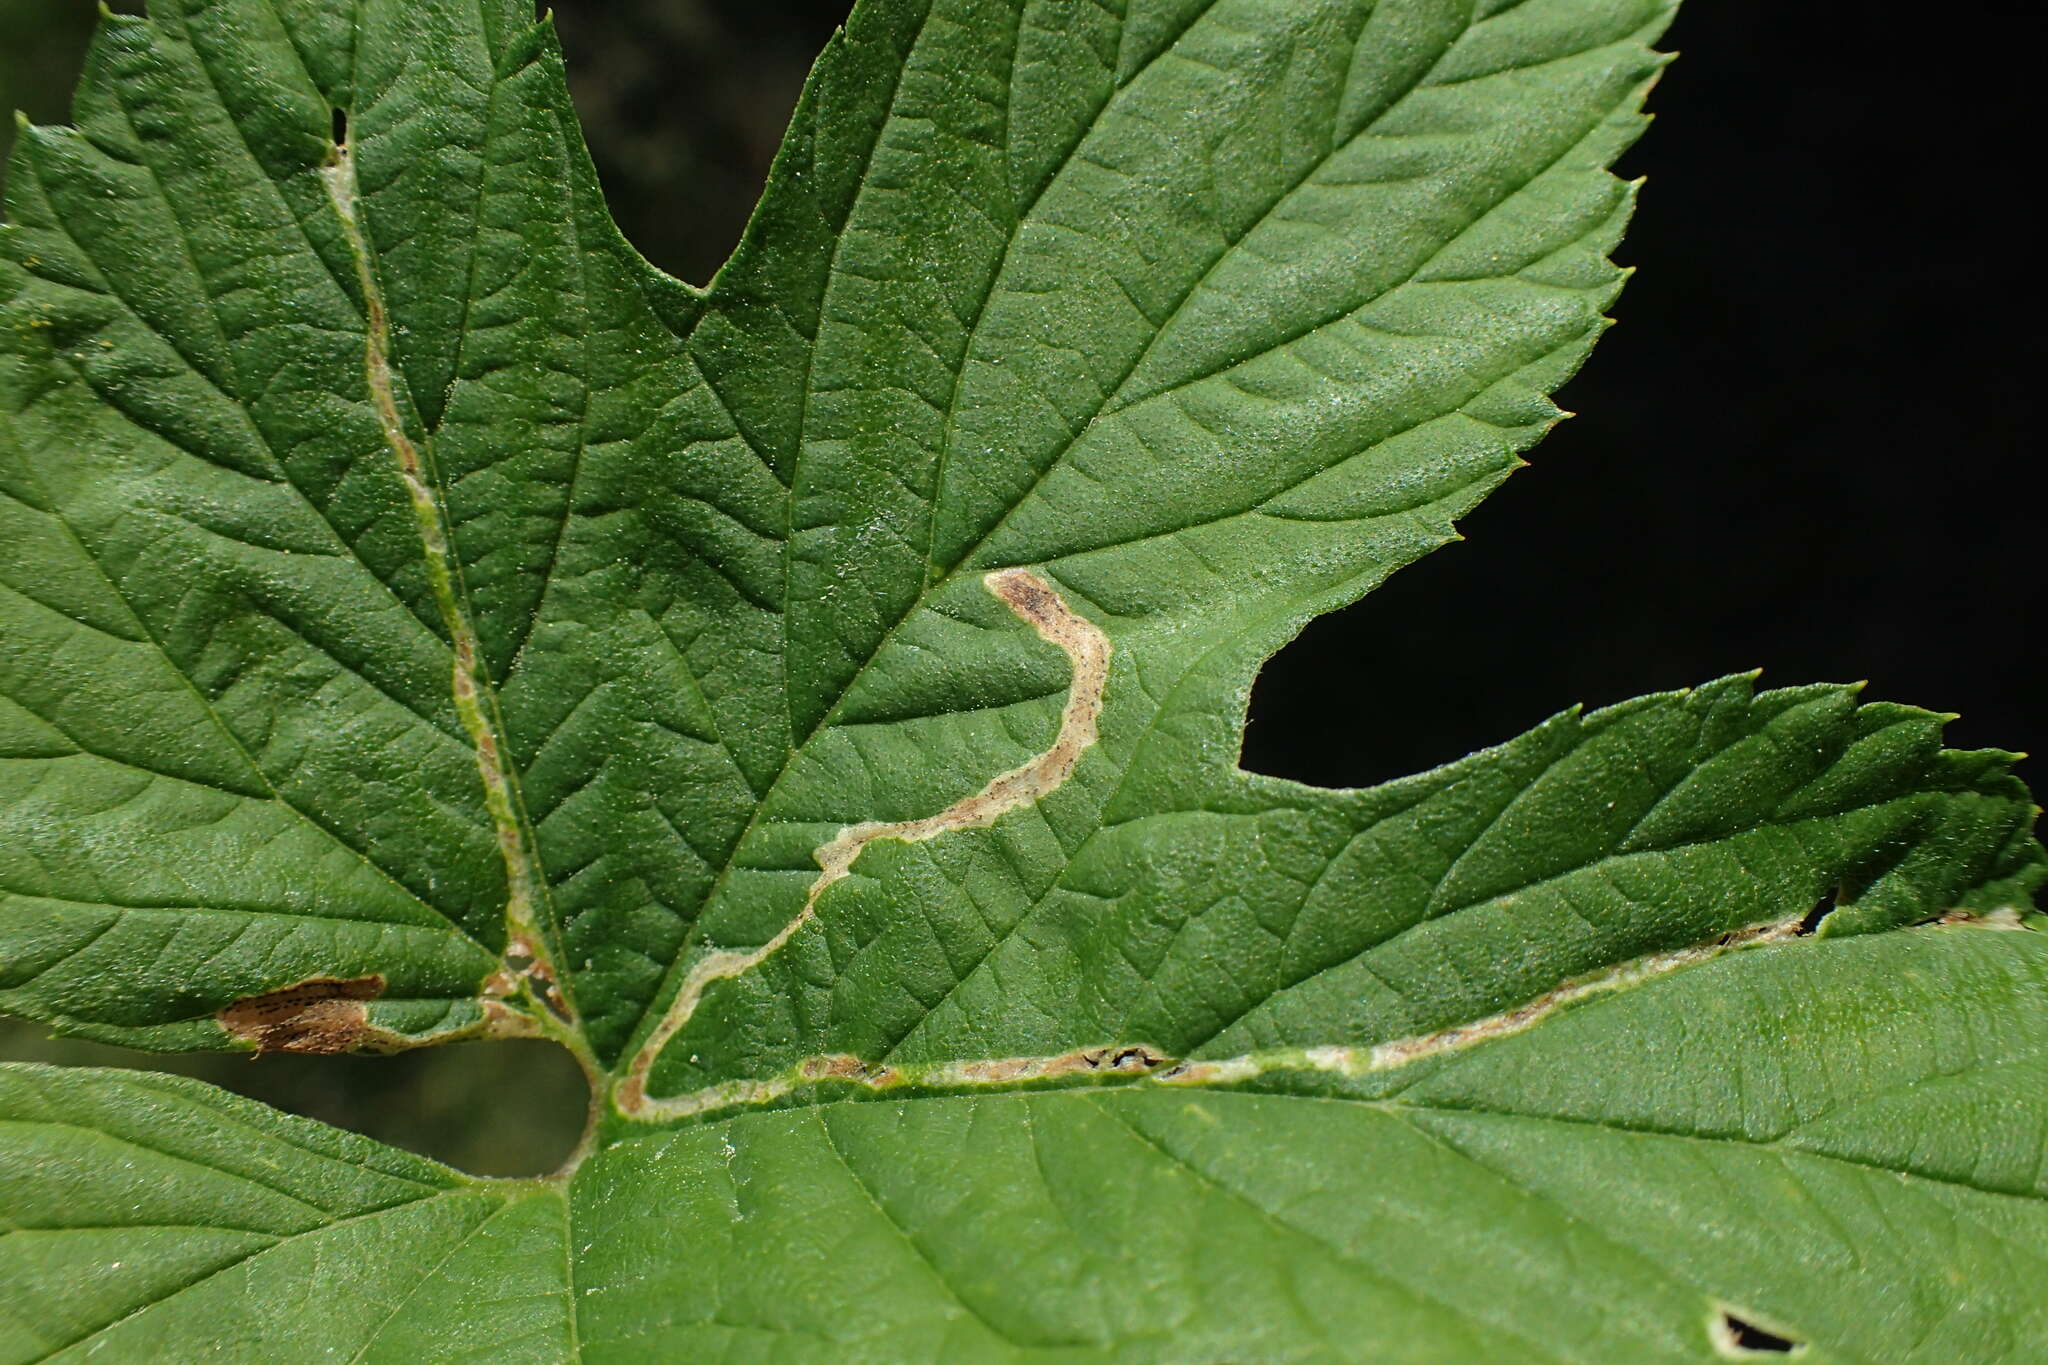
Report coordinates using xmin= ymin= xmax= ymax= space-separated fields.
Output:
xmin=0 ymin=0 xmax=2048 ymax=1173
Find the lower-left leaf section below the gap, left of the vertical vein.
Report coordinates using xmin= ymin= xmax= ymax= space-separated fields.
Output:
xmin=0 ymin=1066 xmax=571 ymax=1361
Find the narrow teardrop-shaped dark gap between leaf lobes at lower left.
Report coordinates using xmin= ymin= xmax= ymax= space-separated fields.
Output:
xmin=0 ymin=1019 xmax=590 ymax=1177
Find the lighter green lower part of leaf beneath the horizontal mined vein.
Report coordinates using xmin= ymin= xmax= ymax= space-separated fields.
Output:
xmin=0 ymin=929 xmax=2048 ymax=1363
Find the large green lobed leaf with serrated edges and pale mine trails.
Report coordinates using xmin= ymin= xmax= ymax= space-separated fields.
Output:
xmin=0 ymin=0 xmax=2048 ymax=1361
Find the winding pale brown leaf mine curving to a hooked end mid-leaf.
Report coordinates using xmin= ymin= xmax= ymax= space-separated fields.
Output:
xmin=614 ymin=569 xmax=1112 ymax=1121
